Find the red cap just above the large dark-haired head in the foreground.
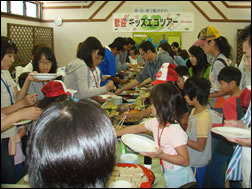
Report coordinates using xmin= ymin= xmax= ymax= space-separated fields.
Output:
xmin=41 ymin=80 xmax=71 ymax=97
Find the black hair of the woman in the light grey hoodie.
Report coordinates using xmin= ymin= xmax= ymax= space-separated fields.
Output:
xmin=77 ymin=37 xmax=105 ymax=67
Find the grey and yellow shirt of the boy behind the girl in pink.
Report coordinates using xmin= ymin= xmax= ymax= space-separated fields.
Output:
xmin=186 ymin=109 xmax=212 ymax=167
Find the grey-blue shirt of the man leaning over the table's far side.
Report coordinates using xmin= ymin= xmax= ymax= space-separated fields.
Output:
xmin=136 ymin=52 xmax=173 ymax=83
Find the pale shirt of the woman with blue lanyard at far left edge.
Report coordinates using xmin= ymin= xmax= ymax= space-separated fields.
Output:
xmin=1 ymin=70 xmax=17 ymax=139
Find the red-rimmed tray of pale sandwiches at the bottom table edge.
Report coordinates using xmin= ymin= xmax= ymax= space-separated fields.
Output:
xmin=108 ymin=163 xmax=155 ymax=188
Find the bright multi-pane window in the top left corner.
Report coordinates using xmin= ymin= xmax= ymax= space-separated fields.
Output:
xmin=1 ymin=1 xmax=41 ymax=19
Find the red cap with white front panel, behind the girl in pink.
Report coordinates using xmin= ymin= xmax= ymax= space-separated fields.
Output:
xmin=152 ymin=63 xmax=178 ymax=85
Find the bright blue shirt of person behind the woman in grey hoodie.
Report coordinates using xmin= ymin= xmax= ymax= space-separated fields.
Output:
xmin=98 ymin=48 xmax=116 ymax=87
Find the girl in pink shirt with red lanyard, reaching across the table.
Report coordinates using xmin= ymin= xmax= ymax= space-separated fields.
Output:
xmin=116 ymin=82 xmax=195 ymax=188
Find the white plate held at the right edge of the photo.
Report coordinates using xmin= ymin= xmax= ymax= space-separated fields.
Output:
xmin=212 ymin=127 xmax=251 ymax=138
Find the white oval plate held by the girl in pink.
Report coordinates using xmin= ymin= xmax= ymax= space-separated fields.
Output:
xmin=121 ymin=134 xmax=158 ymax=152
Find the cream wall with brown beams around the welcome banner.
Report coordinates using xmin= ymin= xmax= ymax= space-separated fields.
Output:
xmin=1 ymin=1 xmax=251 ymax=66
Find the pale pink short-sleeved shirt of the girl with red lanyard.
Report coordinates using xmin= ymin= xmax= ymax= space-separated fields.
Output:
xmin=144 ymin=118 xmax=188 ymax=170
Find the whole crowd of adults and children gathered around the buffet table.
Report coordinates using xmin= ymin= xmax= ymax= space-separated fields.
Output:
xmin=1 ymin=25 xmax=251 ymax=188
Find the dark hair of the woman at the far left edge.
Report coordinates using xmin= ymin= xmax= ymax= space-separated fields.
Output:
xmin=1 ymin=36 xmax=17 ymax=60
